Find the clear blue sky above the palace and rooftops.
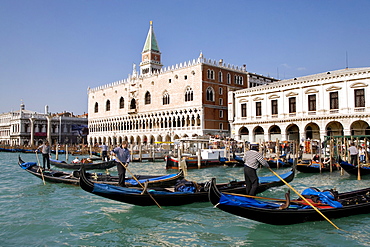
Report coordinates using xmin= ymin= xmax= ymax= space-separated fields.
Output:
xmin=0 ymin=0 xmax=370 ymax=115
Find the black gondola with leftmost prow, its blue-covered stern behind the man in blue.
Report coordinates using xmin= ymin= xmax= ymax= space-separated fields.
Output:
xmin=18 ymin=157 xmax=184 ymax=187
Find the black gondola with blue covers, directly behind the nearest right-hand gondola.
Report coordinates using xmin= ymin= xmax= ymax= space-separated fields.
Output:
xmin=80 ymin=166 xmax=294 ymax=206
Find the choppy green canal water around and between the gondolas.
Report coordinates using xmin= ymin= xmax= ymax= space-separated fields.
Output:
xmin=0 ymin=153 xmax=370 ymax=247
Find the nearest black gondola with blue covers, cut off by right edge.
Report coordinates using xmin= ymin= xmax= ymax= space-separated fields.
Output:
xmin=209 ymin=179 xmax=370 ymax=225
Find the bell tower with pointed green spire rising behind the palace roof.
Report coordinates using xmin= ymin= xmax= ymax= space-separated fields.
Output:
xmin=140 ymin=21 xmax=163 ymax=75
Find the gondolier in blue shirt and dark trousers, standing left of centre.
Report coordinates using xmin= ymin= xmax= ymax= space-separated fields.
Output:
xmin=111 ymin=141 xmax=130 ymax=187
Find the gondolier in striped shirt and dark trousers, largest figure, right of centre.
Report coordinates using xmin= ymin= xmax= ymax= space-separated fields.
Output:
xmin=243 ymin=145 xmax=270 ymax=196
